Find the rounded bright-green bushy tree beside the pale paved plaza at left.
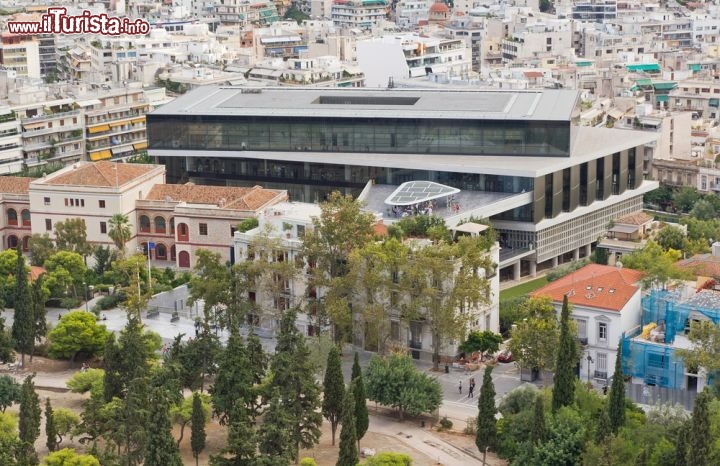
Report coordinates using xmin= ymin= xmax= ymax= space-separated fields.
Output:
xmin=48 ymin=311 xmax=108 ymax=362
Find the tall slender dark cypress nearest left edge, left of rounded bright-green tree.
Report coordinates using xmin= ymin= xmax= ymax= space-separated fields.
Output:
xmin=12 ymin=244 xmax=35 ymax=366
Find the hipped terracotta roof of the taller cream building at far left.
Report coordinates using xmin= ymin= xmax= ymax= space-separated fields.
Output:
xmin=43 ymin=160 xmax=157 ymax=187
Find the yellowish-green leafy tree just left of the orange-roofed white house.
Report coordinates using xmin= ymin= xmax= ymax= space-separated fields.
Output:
xmin=508 ymin=297 xmax=559 ymax=376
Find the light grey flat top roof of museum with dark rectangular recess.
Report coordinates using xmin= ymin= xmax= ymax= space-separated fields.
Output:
xmin=151 ymin=85 xmax=579 ymax=122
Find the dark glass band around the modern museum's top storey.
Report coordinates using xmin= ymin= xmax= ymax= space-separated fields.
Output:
xmin=148 ymin=115 xmax=570 ymax=157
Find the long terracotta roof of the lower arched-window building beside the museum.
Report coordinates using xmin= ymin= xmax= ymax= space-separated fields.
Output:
xmin=145 ymin=184 xmax=287 ymax=211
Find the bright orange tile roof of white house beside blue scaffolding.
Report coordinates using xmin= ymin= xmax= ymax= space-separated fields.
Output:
xmin=533 ymin=264 xmax=643 ymax=312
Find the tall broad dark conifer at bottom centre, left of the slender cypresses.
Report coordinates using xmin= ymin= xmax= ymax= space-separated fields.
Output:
xmin=269 ymin=309 xmax=322 ymax=461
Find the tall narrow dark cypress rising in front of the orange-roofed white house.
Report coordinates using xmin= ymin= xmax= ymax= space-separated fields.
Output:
xmin=552 ymin=295 xmax=579 ymax=412
